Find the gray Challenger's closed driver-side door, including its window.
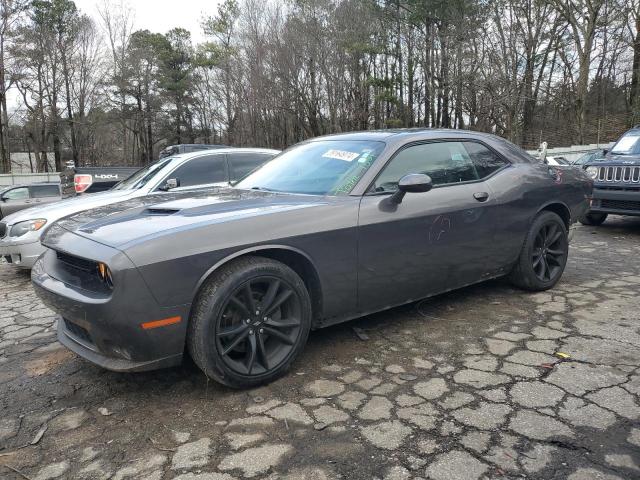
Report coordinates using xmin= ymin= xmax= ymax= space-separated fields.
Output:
xmin=358 ymin=141 xmax=496 ymax=311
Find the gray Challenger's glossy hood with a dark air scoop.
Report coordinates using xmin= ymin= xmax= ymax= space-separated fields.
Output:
xmin=58 ymin=187 xmax=335 ymax=248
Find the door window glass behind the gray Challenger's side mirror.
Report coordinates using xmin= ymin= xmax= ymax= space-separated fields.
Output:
xmin=373 ymin=142 xmax=480 ymax=192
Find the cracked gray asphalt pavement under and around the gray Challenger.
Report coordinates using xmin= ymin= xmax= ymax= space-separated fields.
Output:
xmin=0 ymin=217 xmax=640 ymax=480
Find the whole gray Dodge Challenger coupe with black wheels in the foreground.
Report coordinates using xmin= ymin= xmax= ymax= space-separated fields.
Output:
xmin=32 ymin=129 xmax=592 ymax=388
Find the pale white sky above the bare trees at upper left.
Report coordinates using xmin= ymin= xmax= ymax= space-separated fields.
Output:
xmin=74 ymin=0 xmax=222 ymax=43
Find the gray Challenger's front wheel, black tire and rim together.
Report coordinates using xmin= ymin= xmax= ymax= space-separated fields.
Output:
xmin=187 ymin=257 xmax=312 ymax=388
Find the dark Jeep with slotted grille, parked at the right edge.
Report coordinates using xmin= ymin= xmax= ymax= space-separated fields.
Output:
xmin=580 ymin=125 xmax=640 ymax=225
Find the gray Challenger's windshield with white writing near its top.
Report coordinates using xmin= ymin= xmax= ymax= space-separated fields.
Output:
xmin=236 ymin=140 xmax=385 ymax=195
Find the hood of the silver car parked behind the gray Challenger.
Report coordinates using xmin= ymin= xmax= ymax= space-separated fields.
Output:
xmin=2 ymin=190 xmax=140 ymax=225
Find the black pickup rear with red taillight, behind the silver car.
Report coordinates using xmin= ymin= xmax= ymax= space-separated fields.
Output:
xmin=60 ymin=164 xmax=140 ymax=198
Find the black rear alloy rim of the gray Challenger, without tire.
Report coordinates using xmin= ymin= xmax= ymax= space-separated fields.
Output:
xmin=531 ymin=221 xmax=567 ymax=282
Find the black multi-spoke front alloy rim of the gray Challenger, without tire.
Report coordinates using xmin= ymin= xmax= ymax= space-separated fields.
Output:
xmin=215 ymin=276 xmax=301 ymax=375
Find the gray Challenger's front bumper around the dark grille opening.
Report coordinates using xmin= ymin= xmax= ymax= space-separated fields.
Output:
xmin=31 ymin=246 xmax=190 ymax=372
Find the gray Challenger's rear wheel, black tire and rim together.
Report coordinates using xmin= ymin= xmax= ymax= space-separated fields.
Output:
xmin=508 ymin=211 xmax=569 ymax=291
